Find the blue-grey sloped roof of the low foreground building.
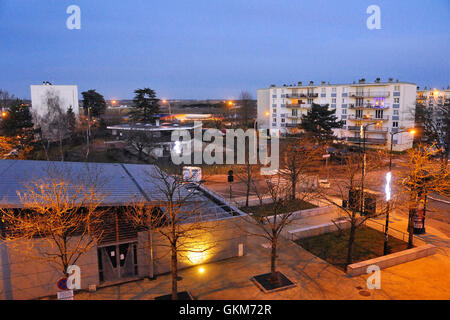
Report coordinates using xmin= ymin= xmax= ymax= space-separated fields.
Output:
xmin=0 ymin=160 xmax=236 ymax=219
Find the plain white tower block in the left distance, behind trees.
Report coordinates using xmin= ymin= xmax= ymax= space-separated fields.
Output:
xmin=30 ymin=82 xmax=79 ymax=117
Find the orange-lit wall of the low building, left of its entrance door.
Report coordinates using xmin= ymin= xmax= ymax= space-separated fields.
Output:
xmin=0 ymin=240 xmax=99 ymax=300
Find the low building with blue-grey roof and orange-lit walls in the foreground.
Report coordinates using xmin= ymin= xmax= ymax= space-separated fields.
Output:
xmin=0 ymin=160 xmax=247 ymax=299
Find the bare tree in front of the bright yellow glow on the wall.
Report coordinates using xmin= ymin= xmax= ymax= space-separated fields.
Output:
xmin=127 ymin=166 xmax=215 ymax=300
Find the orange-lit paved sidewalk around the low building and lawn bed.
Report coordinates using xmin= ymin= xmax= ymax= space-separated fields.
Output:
xmin=76 ymin=214 xmax=450 ymax=300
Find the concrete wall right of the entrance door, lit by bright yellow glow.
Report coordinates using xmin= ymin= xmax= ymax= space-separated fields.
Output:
xmin=138 ymin=217 xmax=247 ymax=277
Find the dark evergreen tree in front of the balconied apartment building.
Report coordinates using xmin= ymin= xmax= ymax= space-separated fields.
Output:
xmin=301 ymin=103 xmax=343 ymax=143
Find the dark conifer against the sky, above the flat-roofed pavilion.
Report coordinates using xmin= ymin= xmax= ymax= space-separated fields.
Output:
xmin=130 ymin=88 xmax=159 ymax=123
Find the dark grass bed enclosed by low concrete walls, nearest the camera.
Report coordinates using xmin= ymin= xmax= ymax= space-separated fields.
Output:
xmin=295 ymin=226 xmax=408 ymax=269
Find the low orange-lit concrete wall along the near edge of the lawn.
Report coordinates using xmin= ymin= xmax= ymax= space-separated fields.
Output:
xmin=347 ymin=244 xmax=437 ymax=277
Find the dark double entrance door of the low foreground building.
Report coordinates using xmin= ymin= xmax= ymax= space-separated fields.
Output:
xmin=97 ymin=242 xmax=138 ymax=282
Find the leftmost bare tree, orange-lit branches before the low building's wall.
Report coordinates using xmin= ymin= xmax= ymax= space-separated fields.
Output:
xmin=0 ymin=166 xmax=105 ymax=275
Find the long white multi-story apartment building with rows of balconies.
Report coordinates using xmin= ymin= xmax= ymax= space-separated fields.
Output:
xmin=258 ymin=78 xmax=417 ymax=151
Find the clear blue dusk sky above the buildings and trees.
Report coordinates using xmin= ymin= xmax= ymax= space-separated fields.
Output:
xmin=0 ymin=0 xmax=450 ymax=99
